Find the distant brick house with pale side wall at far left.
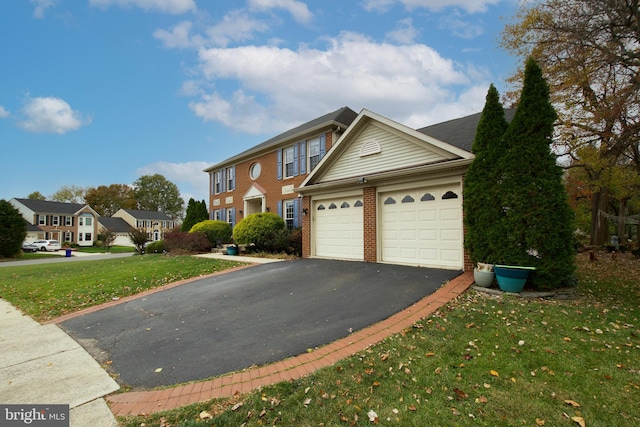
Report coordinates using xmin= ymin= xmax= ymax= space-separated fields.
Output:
xmin=9 ymin=198 xmax=98 ymax=246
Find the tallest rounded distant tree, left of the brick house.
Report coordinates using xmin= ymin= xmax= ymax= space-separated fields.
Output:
xmin=133 ymin=174 xmax=184 ymax=219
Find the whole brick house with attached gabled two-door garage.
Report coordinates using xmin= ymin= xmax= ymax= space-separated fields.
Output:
xmin=206 ymin=110 xmax=513 ymax=270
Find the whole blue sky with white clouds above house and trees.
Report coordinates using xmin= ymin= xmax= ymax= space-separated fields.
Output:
xmin=0 ymin=0 xmax=518 ymax=207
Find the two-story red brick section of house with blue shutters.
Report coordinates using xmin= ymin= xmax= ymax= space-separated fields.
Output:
xmin=205 ymin=107 xmax=357 ymax=228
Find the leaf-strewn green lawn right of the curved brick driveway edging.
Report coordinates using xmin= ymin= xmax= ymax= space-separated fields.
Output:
xmin=119 ymin=255 xmax=640 ymax=427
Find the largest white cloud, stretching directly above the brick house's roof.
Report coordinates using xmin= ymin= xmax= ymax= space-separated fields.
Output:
xmin=190 ymin=33 xmax=489 ymax=134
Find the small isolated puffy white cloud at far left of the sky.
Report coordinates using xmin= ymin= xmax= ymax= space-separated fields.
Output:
xmin=18 ymin=97 xmax=91 ymax=134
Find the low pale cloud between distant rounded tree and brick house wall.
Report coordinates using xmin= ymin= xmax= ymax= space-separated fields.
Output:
xmin=136 ymin=162 xmax=213 ymax=204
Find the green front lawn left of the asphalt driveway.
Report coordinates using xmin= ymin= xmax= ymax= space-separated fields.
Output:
xmin=0 ymin=254 xmax=242 ymax=321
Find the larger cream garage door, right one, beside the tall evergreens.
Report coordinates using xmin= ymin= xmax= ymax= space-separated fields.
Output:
xmin=378 ymin=184 xmax=464 ymax=269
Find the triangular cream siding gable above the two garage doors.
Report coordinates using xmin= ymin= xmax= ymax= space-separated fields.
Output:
xmin=319 ymin=123 xmax=452 ymax=182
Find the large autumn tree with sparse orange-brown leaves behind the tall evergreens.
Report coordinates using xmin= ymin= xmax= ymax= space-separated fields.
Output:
xmin=502 ymin=0 xmax=640 ymax=245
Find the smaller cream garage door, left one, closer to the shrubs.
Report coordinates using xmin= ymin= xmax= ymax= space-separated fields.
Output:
xmin=312 ymin=196 xmax=364 ymax=261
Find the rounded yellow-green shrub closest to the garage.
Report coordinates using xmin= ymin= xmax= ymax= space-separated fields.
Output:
xmin=233 ymin=212 xmax=288 ymax=252
